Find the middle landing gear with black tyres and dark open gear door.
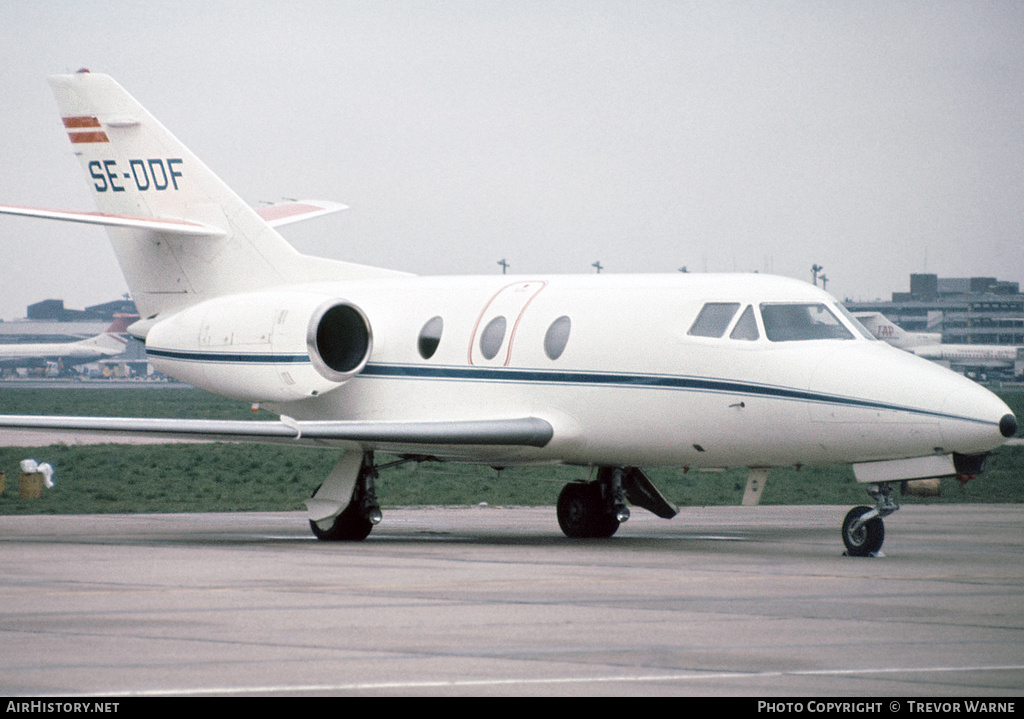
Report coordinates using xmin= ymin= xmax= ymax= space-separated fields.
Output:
xmin=557 ymin=467 xmax=679 ymax=539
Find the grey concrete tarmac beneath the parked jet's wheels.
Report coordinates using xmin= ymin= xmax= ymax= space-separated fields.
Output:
xmin=0 ymin=505 xmax=1024 ymax=696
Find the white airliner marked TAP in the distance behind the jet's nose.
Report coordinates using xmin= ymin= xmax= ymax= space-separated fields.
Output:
xmin=856 ymin=312 xmax=1024 ymax=385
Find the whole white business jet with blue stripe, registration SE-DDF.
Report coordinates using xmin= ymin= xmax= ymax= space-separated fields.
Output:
xmin=0 ymin=71 xmax=1017 ymax=555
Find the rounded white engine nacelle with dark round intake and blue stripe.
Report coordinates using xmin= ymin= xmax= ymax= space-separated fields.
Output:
xmin=145 ymin=291 xmax=373 ymax=401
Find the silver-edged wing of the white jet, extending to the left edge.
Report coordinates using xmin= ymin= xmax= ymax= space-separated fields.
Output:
xmin=0 ymin=415 xmax=554 ymax=449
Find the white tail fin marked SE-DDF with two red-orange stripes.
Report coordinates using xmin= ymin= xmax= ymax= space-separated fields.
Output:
xmin=45 ymin=71 xmax=397 ymax=318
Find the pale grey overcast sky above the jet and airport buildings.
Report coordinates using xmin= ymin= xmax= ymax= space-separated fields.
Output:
xmin=0 ymin=0 xmax=1024 ymax=320
